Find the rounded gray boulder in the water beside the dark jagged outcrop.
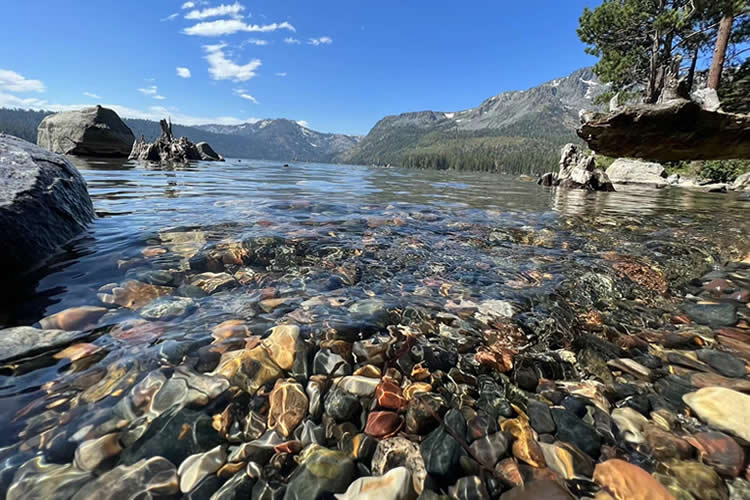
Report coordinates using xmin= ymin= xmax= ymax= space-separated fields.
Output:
xmin=36 ymin=106 xmax=135 ymax=157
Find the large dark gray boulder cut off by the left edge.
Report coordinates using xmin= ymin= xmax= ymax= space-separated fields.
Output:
xmin=0 ymin=134 xmax=94 ymax=279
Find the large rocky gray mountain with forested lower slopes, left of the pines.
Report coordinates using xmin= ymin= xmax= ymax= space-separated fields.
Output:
xmin=338 ymin=68 xmax=606 ymax=173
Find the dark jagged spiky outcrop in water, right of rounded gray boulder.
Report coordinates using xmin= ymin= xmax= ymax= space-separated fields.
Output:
xmin=128 ymin=120 xmax=224 ymax=163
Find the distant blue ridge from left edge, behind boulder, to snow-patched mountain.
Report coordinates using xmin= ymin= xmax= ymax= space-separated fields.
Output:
xmin=0 ymin=108 xmax=361 ymax=162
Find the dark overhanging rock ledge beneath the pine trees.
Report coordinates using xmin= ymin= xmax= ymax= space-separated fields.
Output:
xmin=578 ymin=99 xmax=750 ymax=161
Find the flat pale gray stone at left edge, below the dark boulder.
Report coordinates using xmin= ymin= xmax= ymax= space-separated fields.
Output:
xmin=0 ymin=326 xmax=85 ymax=363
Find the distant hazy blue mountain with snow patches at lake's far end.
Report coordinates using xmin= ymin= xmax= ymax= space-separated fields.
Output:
xmin=197 ymin=119 xmax=362 ymax=161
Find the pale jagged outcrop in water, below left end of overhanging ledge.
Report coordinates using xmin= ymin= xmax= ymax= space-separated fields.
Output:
xmin=537 ymin=144 xmax=615 ymax=191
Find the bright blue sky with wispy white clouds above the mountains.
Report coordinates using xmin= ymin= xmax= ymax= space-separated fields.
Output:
xmin=0 ymin=0 xmax=600 ymax=134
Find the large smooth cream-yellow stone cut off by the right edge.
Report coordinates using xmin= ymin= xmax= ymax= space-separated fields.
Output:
xmin=683 ymin=387 xmax=750 ymax=441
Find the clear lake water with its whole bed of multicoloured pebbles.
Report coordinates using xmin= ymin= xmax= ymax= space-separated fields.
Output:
xmin=0 ymin=154 xmax=750 ymax=500
